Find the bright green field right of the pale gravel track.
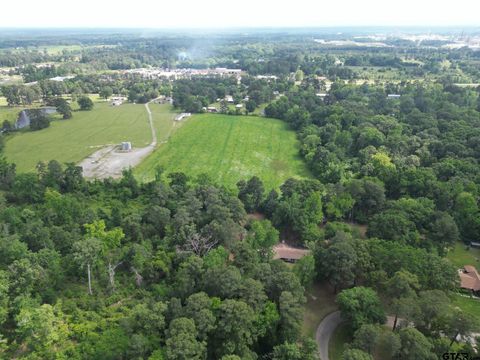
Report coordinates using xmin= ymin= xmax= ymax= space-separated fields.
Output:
xmin=136 ymin=114 xmax=308 ymax=189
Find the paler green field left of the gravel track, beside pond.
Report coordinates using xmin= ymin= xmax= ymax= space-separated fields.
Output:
xmin=5 ymin=102 xmax=151 ymax=172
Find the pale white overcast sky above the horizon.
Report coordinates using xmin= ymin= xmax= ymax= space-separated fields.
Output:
xmin=0 ymin=0 xmax=480 ymax=29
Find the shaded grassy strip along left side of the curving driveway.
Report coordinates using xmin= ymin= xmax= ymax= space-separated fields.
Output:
xmin=302 ymin=282 xmax=338 ymax=338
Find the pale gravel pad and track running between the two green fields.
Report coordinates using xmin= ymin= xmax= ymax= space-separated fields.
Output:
xmin=79 ymin=99 xmax=157 ymax=179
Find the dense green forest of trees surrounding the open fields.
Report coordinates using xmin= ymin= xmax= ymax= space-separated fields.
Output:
xmin=0 ymin=30 xmax=480 ymax=360
